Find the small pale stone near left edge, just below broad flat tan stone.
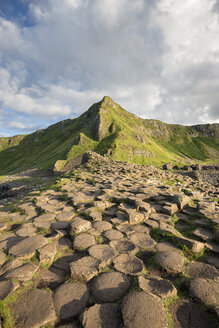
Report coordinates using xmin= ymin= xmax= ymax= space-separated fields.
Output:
xmin=4 ymin=263 xmax=38 ymax=281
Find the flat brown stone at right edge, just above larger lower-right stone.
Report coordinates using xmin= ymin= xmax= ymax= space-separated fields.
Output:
xmin=183 ymin=261 xmax=219 ymax=279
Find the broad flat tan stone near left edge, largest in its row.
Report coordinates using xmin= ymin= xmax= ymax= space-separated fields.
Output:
xmin=9 ymin=235 xmax=48 ymax=258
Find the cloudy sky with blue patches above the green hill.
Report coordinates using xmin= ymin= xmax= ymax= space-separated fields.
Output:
xmin=0 ymin=0 xmax=219 ymax=137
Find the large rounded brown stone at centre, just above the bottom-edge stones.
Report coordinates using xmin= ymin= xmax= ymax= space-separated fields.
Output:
xmin=91 ymin=272 xmax=130 ymax=303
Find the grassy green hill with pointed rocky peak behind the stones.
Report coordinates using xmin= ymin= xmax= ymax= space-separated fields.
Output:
xmin=0 ymin=97 xmax=219 ymax=174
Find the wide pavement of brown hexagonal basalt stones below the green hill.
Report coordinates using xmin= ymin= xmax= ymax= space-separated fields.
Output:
xmin=0 ymin=154 xmax=219 ymax=328
